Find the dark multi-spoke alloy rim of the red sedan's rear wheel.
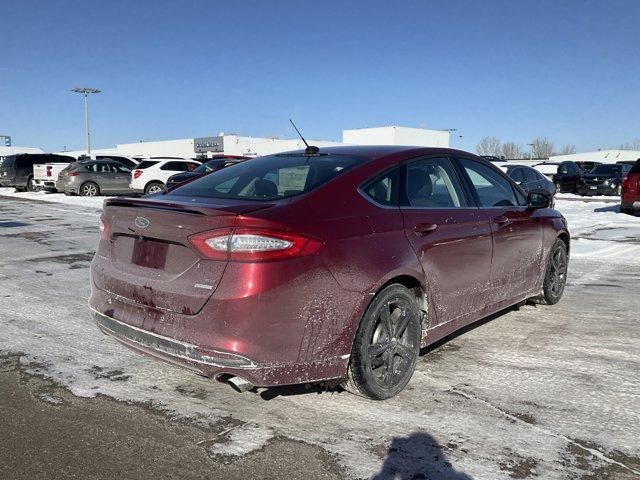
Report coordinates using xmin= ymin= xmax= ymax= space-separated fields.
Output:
xmin=369 ymin=298 xmax=418 ymax=388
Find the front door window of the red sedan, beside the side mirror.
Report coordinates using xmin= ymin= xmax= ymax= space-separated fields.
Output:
xmin=460 ymin=158 xmax=518 ymax=207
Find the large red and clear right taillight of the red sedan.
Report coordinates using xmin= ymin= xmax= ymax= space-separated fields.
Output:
xmin=189 ymin=228 xmax=322 ymax=262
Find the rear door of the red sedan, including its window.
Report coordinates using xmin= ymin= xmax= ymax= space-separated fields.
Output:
xmin=400 ymin=156 xmax=492 ymax=328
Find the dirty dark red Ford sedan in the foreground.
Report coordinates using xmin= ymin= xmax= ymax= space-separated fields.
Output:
xmin=89 ymin=146 xmax=569 ymax=399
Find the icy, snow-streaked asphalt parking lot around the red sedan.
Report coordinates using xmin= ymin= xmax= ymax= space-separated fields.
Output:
xmin=0 ymin=193 xmax=640 ymax=480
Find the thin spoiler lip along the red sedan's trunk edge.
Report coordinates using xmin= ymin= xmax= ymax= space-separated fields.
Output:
xmin=104 ymin=197 xmax=275 ymax=216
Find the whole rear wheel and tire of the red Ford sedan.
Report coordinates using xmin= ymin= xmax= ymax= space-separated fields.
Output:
xmin=345 ymin=284 xmax=422 ymax=400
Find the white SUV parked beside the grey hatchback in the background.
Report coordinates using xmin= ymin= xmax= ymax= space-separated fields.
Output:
xmin=129 ymin=157 xmax=200 ymax=195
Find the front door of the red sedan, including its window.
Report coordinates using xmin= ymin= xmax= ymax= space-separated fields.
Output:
xmin=458 ymin=158 xmax=542 ymax=304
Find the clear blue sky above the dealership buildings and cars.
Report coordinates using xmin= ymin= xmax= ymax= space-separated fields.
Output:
xmin=0 ymin=0 xmax=640 ymax=151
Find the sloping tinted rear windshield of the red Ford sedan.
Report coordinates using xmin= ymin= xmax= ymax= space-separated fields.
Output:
xmin=171 ymin=155 xmax=363 ymax=200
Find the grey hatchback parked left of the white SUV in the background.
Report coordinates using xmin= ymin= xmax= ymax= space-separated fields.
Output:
xmin=56 ymin=159 xmax=131 ymax=197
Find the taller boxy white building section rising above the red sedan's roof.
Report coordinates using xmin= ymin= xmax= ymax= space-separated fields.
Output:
xmin=342 ymin=126 xmax=449 ymax=148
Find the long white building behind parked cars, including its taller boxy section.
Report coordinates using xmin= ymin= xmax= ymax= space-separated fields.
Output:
xmin=61 ymin=127 xmax=449 ymax=158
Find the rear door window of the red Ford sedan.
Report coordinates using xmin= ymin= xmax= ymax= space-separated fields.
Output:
xmin=403 ymin=158 xmax=466 ymax=208
